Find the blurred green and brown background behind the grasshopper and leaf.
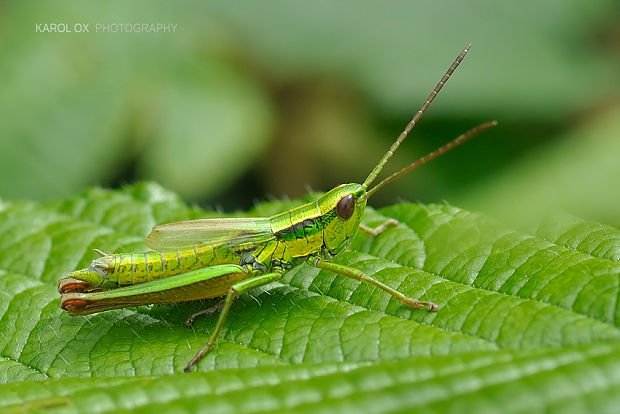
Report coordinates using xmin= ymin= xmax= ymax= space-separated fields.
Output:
xmin=0 ymin=0 xmax=620 ymax=223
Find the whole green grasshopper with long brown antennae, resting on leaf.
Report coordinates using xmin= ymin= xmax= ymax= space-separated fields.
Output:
xmin=58 ymin=45 xmax=496 ymax=372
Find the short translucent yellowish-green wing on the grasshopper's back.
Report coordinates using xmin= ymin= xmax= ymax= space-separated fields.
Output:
xmin=146 ymin=218 xmax=274 ymax=251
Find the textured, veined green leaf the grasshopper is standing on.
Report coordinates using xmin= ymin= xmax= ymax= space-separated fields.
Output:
xmin=0 ymin=183 xmax=620 ymax=413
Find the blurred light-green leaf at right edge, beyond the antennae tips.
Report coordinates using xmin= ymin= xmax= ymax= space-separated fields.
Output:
xmin=461 ymin=106 xmax=620 ymax=223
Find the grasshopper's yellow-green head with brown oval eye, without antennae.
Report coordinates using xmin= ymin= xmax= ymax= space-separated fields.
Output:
xmin=317 ymin=184 xmax=367 ymax=254
